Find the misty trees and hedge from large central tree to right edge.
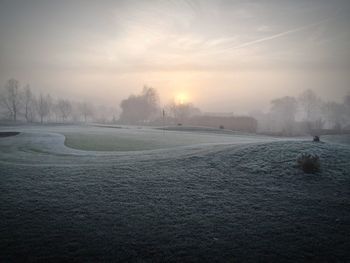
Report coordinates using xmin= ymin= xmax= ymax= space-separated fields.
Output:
xmin=120 ymin=87 xmax=350 ymax=135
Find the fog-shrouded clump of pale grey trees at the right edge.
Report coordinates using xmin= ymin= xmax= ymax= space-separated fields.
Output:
xmin=251 ymin=89 xmax=350 ymax=135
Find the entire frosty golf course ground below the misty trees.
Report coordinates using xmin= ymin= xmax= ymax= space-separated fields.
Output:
xmin=0 ymin=126 xmax=350 ymax=262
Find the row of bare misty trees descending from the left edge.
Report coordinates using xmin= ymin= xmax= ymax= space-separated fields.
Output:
xmin=0 ymin=79 xmax=116 ymax=124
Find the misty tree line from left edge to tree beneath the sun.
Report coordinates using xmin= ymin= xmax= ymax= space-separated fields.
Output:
xmin=0 ymin=79 xmax=200 ymax=125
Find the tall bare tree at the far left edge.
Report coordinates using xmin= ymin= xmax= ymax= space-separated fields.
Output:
xmin=0 ymin=79 xmax=22 ymax=122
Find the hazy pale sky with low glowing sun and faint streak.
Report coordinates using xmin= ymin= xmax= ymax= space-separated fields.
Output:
xmin=0 ymin=0 xmax=350 ymax=113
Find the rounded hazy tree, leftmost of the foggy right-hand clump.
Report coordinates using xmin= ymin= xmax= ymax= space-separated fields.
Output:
xmin=271 ymin=96 xmax=297 ymax=134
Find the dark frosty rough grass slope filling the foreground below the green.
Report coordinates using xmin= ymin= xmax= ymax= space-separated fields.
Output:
xmin=0 ymin=142 xmax=350 ymax=262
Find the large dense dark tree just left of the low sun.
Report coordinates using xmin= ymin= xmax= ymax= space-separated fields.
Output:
xmin=120 ymin=86 xmax=159 ymax=124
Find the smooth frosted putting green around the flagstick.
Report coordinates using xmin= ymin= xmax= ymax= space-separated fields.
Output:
xmin=62 ymin=127 xmax=272 ymax=151
